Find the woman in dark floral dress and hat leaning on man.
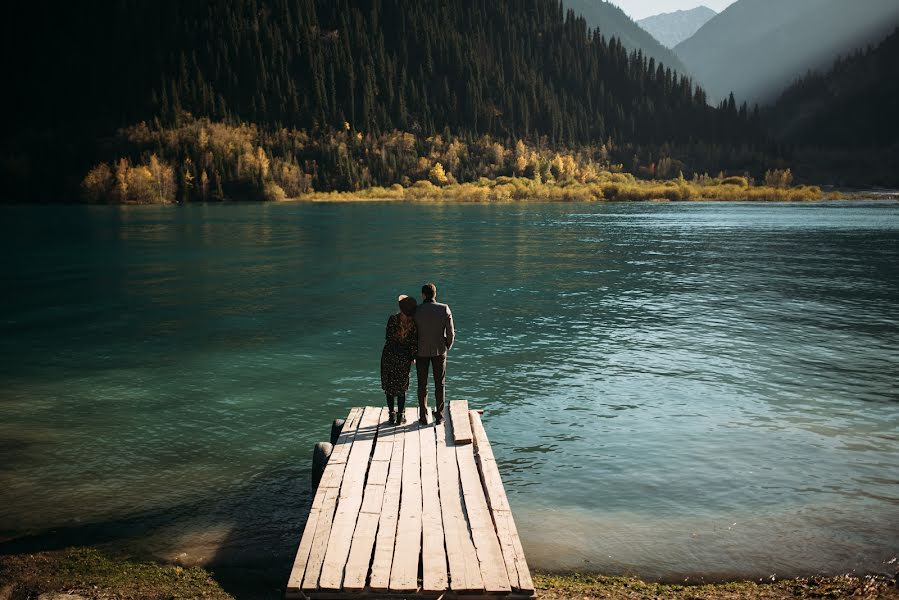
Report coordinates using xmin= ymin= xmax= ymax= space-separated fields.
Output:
xmin=381 ymin=294 xmax=418 ymax=425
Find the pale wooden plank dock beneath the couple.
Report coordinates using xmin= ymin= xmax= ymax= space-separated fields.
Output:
xmin=285 ymin=401 xmax=534 ymax=600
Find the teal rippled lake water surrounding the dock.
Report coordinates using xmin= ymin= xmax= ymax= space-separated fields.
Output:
xmin=0 ymin=201 xmax=899 ymax=579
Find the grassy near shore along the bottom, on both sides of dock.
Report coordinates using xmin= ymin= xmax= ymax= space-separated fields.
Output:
xmin=0 ymin=548 xmax=899 ymax=600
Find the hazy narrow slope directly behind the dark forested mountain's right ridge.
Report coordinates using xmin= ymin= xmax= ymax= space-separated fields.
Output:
xmin=562 ymin=0 xmax=688 ymax=74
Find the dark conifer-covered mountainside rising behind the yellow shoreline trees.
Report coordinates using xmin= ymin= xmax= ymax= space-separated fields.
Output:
xmin=2 ymin=0 xmax=760 ymax=198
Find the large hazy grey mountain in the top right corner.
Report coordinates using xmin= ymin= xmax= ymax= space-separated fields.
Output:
xmin=674 ymin=0 xmax=899 ymax=104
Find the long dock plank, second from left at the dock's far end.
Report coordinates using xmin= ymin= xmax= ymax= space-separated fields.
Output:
xmin=318 ymin=406 xmax=386 ymax=590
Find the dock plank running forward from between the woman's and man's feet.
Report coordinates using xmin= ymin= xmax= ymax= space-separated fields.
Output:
xmin=390 ymin=408 xmax=423 ymax=592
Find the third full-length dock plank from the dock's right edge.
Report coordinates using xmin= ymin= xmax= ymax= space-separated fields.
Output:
xmin=435 ymin=421 xmax=484 ymax=591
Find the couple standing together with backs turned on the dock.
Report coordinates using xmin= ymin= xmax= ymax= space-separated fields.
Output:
xmin=381 ymin=283 xmax=455 ymax=425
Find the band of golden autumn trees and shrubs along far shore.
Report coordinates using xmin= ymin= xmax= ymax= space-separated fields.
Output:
xmin=82 ymin=113 xmax=820 ymax=203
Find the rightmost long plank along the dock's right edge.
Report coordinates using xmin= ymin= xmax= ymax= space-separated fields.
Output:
xmin=469 ymin=410 xmax=534 ymax=592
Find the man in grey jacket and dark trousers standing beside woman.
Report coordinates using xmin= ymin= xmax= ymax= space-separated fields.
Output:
xmin=415 ymin=283 xmax=455 ymax=425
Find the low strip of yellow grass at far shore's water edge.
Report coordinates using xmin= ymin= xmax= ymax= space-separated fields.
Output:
xmin=299 ymin=173 xmax=824 ymax=202
